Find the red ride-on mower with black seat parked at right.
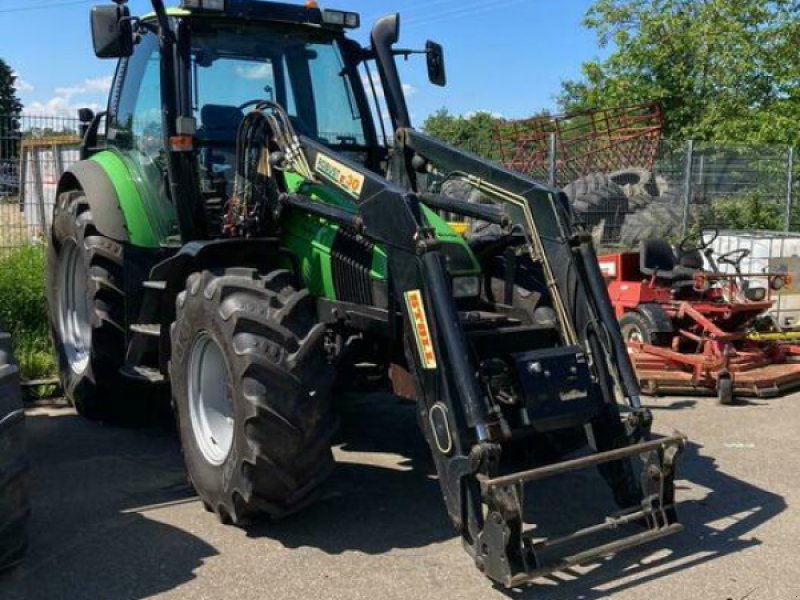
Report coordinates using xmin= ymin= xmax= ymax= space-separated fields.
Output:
xmin=599 ymin=230 xmax=800 ymax=404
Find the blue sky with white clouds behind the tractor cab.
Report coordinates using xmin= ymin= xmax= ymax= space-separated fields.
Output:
xmin=0 ymin=0 xmax=599 ymax=123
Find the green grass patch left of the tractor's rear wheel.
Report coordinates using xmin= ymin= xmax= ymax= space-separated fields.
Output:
xmin=0 ymin=244 xmax=56 ymax=393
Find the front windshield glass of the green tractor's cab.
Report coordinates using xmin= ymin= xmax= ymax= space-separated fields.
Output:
xmin=192 ymin=20 xmax=369 ymax=150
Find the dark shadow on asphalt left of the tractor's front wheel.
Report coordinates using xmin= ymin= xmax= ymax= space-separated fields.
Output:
xmin=0 ymin=410 xmax=217 ymax=600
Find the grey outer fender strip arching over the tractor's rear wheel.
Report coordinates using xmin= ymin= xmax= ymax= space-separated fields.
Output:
xmin=57 ymin=160 xmax=129 ymax=242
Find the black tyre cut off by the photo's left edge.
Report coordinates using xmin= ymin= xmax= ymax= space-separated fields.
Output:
xmin=0 ymin=333 xmax=30 ymax=570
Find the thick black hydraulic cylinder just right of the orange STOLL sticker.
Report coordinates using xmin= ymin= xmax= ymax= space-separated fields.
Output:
xmin=421 ymin=251 xmax=489 ymax=441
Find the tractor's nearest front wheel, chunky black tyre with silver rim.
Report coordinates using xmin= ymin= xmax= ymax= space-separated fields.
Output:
xmin=170 ymin=269 xmax=336 ymax=525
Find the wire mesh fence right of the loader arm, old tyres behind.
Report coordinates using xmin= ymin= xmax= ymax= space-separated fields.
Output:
xmin=467 ymin=135 xmax=800 ymax=247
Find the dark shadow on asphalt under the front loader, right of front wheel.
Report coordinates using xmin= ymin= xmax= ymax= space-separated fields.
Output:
xmin=248 ymin=397 xmax=786 ymax=600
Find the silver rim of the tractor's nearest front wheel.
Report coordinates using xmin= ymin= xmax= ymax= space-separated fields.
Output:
xmin=189 ymin=332 xmax=233 ymax=466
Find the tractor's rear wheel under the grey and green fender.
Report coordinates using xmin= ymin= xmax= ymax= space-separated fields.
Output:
xmin=47 ymin=190 xmax=143 ymax=424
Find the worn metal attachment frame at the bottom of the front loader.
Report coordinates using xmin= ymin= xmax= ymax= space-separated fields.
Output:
xmin=476 ymin=432 xmax=687 ymax=587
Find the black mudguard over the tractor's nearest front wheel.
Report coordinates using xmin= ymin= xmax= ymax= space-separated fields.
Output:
xmin=150 ymin=238 xmax=284 ymax=373
